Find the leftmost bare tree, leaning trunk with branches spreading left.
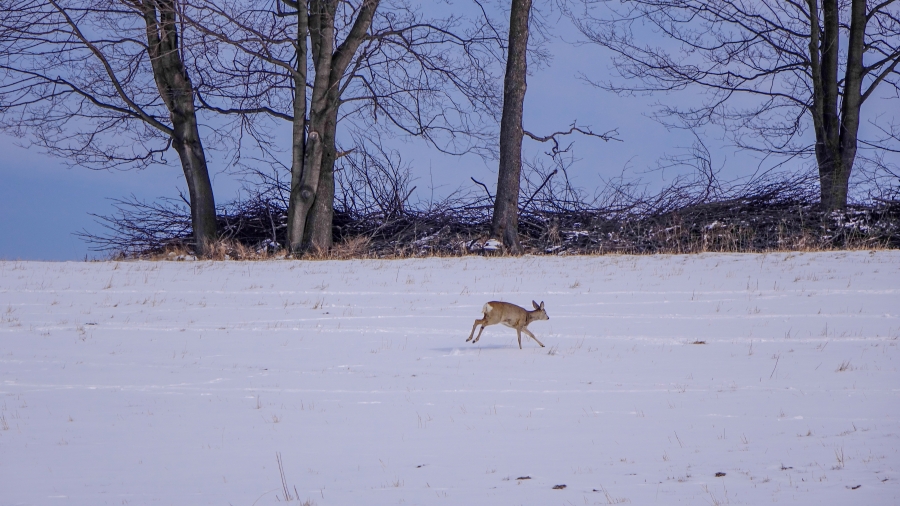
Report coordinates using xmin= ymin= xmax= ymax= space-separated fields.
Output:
xmin=0 ymin=0 xmax=216 ymax=254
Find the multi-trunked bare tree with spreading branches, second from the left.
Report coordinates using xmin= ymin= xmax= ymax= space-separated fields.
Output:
xmin=192 ymin=0 xmax=499 ymax=252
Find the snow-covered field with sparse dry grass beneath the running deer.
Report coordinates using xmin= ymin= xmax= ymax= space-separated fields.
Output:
xmin=0 ymin=251 xmax=900 ymax=506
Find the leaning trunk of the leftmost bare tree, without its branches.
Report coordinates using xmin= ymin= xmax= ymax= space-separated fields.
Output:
xmin=141 ymin=0 xmax=216 ymax=256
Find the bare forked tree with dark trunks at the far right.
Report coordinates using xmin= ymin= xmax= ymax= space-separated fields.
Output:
xmin=569 ymin=0 xmax=900 ymax=211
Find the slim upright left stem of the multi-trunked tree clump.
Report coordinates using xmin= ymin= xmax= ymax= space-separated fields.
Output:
xmin=286 ymin=1 xmax=309 ymax=252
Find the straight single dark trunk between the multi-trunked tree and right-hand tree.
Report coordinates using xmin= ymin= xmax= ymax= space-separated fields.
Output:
xmin=491 ymin=0 xmax=531 ymax=255
